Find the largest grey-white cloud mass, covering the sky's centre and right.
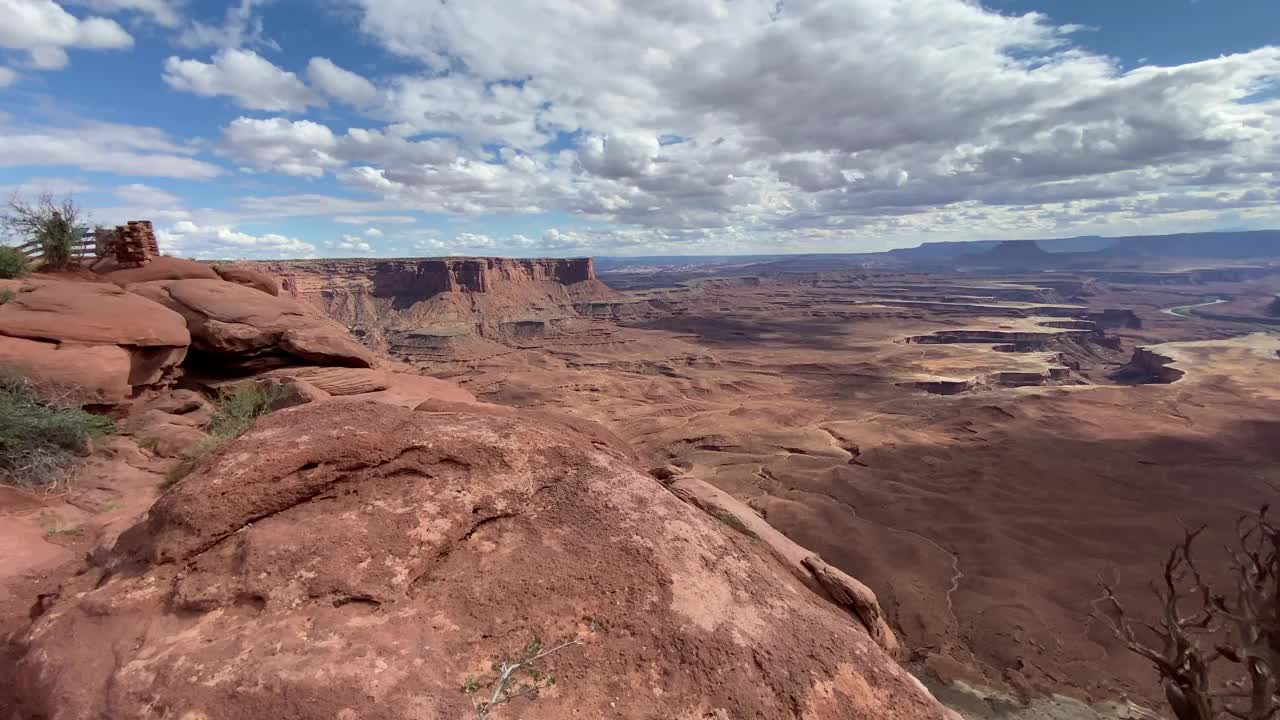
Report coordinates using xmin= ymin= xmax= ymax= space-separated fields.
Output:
xmin=299 ymin=0 xmax=1280 ymax=247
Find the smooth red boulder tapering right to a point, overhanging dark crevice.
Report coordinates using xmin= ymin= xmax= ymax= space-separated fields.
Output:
xmin=129 ymin=279 xmax=372 ymax=368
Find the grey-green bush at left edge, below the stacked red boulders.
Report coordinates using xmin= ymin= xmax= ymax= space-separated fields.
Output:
xmin=0 ymin=372 xmax=114 ymax=488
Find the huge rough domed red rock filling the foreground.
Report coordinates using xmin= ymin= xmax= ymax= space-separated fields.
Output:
xmin=17 ymin=400 xmax=948 ymax=720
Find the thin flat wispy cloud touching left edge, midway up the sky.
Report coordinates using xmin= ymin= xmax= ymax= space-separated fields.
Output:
xmin=0 ymin=123 xmax=223 ymax=179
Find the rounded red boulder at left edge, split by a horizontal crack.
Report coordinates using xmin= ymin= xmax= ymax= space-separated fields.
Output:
xmin=0 ymin=279 xmax=191 ymax=404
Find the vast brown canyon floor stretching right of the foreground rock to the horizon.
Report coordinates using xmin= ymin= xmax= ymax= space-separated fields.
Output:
xmin=276 ymin=256 xmax=1280 ymax=716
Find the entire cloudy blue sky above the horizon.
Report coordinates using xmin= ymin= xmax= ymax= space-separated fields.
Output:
xmin=0 ymin=0 xmax=1280 ymax=258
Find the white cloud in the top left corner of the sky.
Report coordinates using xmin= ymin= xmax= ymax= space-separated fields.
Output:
xmin=0 ymin=0 xmax=133 ymax=70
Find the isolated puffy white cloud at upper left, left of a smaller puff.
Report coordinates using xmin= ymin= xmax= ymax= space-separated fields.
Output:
xmin=164 ymin=49 xmax=324 ymax=113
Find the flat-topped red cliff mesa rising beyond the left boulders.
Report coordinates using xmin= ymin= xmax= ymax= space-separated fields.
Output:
xmin=255 ymin=258 xmax=620 ymax=360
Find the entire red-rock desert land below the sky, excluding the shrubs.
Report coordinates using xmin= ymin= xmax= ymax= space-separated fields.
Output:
xmin=0 ymin=234 xmax=1280 ymax=720
